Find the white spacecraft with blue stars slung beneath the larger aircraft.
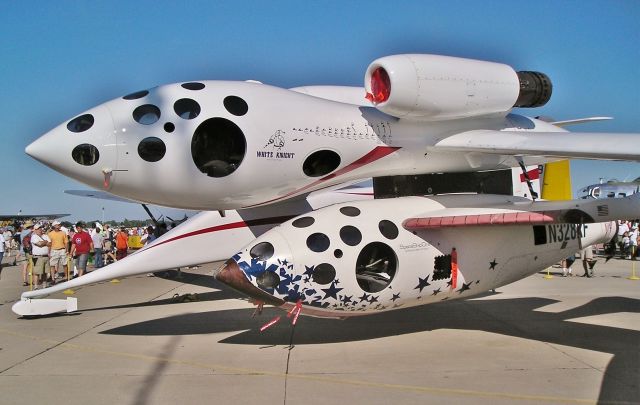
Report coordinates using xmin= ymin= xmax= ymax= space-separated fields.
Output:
xmin=216 ymin=195 xmax=624 ymax=317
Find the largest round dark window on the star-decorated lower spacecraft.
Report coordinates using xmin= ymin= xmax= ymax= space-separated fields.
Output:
xmin=356 ymin=242 xmax=398 ymax=293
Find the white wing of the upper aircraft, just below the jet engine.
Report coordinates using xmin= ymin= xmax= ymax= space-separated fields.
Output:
xmin=433 ymin=130 xmax=640 ymax=161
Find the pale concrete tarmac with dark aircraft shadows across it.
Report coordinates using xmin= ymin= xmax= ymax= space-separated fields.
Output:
xmin=0 ymin=254 xmax=640 ymax=405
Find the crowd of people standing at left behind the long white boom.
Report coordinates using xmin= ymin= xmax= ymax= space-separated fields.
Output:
xmin=0 ymin=221 xmax=167 ymax=289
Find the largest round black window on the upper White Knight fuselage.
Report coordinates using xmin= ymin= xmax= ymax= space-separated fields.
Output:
xmin=191 ymin=118 xmax=247 ymax=177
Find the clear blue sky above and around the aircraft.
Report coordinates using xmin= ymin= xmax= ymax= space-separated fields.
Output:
xmin=0 ymin=0 xmax=640 ymax=220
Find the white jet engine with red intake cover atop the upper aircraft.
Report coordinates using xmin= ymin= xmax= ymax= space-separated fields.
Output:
xmin=364 ymin=54 xmax=551 ymax=120
